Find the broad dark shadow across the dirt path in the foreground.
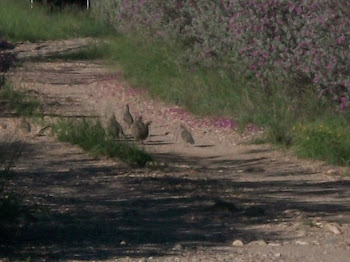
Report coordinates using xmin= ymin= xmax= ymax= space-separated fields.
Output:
xmin=1 ymin=146 xmax=350 ymax=261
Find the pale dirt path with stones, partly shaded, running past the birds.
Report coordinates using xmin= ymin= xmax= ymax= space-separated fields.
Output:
xmin=0 ymin=39 xmax=350 ymax=262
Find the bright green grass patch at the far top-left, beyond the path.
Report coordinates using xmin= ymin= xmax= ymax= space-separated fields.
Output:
xmin=0 ymin=0 xmax=111 ymax=41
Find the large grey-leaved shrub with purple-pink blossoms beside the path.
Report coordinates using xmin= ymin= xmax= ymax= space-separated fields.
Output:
xmin=96 ymin=0 xmax=350 ymax=108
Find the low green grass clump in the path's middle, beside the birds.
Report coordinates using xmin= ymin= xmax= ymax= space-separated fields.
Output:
xmin=53 ymin=119 xmax=152 ymax=167
